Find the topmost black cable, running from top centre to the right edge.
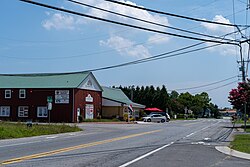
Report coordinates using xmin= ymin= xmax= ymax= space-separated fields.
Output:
xmin=105 ymin=0 xmax=250 ymax=27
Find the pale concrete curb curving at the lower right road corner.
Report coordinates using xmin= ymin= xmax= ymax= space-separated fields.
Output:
xmin=215 ymin=146 xmax=250 ymax=160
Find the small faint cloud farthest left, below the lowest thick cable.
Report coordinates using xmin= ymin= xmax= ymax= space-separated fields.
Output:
xmin=42 ymin=13 xmax=77 ymax=30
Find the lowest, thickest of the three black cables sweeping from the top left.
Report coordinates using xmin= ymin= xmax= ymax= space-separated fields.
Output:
xmin=20 ymin=0 xmax=238 ymax=45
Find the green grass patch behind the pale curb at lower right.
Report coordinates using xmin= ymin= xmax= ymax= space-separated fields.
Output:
xmin=231 ymin=134 xmax=250 ymax=154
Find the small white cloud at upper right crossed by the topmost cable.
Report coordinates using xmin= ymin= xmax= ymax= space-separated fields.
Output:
xmin=201 ymin=15 xmax=234 ymax=34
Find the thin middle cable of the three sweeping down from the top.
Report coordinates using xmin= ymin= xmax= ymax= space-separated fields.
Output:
xmin=68 ymin=0 xmax=233 ymax=42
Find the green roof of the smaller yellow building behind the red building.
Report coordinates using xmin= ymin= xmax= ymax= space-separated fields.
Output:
xmin=102 ymin=86 xmax=145 ymax=108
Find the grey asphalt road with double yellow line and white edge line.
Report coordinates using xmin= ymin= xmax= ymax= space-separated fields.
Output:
xmin=0 ymin=119 xmax=250 ymax=167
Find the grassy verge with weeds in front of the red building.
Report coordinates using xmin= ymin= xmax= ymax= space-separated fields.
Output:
xmin=0 ymin=122 xmax=81 ymax=139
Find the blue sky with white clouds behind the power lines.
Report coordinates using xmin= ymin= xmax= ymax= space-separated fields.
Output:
xmin=0 ymin=0 xmax=250 ymax=108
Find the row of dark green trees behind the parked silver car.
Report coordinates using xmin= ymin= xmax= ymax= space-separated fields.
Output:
xmin=114 ymin=85 xmax=219 ymax=118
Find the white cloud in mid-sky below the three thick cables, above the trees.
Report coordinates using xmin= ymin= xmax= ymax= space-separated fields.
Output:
xmin=100 ymin=36 xmax=150 ymax=58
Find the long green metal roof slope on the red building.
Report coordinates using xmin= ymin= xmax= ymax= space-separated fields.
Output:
xmin=0 ymin=72 xmax=90 ymax=88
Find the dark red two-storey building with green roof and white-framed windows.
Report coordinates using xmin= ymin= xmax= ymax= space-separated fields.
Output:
xmin=0 ymin=72 xmax=102 ymax=122
